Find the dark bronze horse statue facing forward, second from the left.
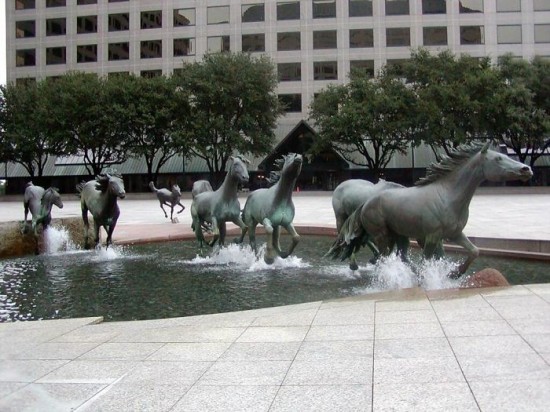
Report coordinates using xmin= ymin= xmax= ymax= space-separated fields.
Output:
xmin=76 ymin=173 xmax=126 ymax=249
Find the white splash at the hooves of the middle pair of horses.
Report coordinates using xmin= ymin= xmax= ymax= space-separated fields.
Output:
xmin=185 ymin=244 xmax=310 ymax=272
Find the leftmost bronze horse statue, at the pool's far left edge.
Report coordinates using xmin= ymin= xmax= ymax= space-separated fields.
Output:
xmin=23 ymin=182 xmax=63 ymax=236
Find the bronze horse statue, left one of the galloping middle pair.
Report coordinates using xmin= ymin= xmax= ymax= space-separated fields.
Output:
xmin=191 ymin=156 xmax=248 ymax=248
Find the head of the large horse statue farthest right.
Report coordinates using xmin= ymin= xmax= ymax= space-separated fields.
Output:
xmin=479 ymin=144 xmax=533 ymax=182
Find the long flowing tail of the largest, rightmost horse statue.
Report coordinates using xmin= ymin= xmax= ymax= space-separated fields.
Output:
xmin=325 ymin=206 xmax=368 ymax=260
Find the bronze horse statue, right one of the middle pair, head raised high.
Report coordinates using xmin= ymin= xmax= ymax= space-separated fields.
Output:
xmin=240 ymin=153 xmax=303 ymax=264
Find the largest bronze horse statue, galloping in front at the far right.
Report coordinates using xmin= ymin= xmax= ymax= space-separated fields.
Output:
xmin=327 ymin=143 xmax=533 ymax=278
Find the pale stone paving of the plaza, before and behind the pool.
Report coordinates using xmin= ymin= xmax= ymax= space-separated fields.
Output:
xmin=0 ymin=188 xmax=550 ymax=412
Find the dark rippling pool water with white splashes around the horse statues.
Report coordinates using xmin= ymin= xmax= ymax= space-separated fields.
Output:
xmin=0 ymin=236 xmax=550 ymax=321
